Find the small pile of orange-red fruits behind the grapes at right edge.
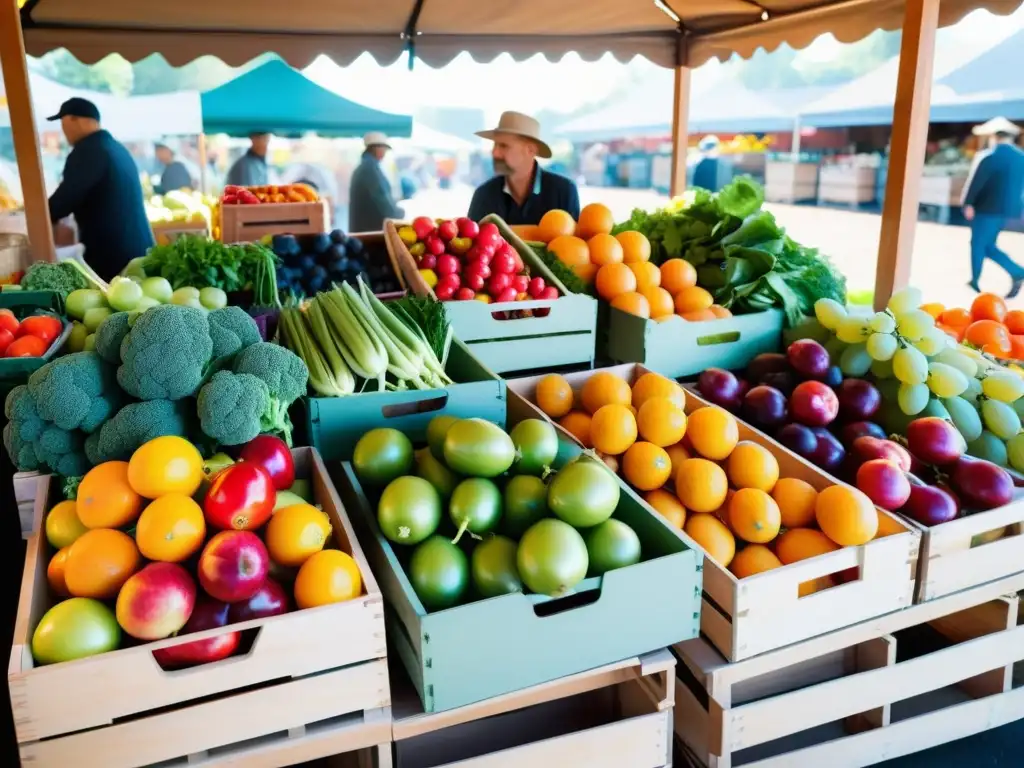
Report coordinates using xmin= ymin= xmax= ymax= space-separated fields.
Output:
xmin=933 ymin=293 xmax=1024 ymax=360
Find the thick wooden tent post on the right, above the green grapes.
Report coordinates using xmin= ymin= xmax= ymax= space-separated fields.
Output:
xmin=874 ymin=0 xmax=939 ymax=309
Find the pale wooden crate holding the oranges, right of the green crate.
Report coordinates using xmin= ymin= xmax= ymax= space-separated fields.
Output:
xmin=508 ymin=366 xmax=921 ymax=660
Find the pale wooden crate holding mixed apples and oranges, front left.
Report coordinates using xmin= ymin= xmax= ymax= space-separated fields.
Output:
xmin=7 ymin=449 xmax=390 ymax=768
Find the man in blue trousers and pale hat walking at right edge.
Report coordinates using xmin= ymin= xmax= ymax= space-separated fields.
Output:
xmin=962 ymin=118 xmax=1024 ymax=299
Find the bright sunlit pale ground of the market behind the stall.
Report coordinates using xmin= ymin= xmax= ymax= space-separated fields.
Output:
xmin=403 ymin=186 xmax=1024 ymax=306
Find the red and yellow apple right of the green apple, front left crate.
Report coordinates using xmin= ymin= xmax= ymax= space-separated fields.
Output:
xmin=117 ymin=561 xmax=196 ymax=640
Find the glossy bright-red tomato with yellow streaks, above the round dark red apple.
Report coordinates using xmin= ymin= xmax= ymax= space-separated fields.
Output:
xmin=203 ymin=461 xmax=278 ymax=530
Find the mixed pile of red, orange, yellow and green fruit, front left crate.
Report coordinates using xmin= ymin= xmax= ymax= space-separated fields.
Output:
xmin=32 ymin=436 xmax=362 ymax=670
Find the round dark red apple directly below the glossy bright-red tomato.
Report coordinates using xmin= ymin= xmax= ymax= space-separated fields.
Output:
xmin=198 ymin=530 xmax=270 ymax=603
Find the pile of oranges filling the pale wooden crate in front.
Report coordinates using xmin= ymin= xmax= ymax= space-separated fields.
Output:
xmin=535 ymin=371 xmax=898 ymax=595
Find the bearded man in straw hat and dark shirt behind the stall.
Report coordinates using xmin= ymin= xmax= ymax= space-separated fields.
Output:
xmin=468 ymin=112 xmax=580 ymax=224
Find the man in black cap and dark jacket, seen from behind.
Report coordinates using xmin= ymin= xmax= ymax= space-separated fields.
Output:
xmin=49 ymin=97 xmax=153 ymax=281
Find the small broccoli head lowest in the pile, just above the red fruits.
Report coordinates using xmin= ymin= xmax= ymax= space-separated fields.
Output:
xmin=197 ymin=371 xmax=272 ymax=445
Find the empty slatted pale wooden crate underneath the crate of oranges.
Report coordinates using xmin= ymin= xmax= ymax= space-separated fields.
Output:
xmin=674 ymin=574 xmax=1024 ymax=768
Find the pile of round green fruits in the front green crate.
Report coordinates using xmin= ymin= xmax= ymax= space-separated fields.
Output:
xmin=352 ymin=416 xmax=642 ymax=611
